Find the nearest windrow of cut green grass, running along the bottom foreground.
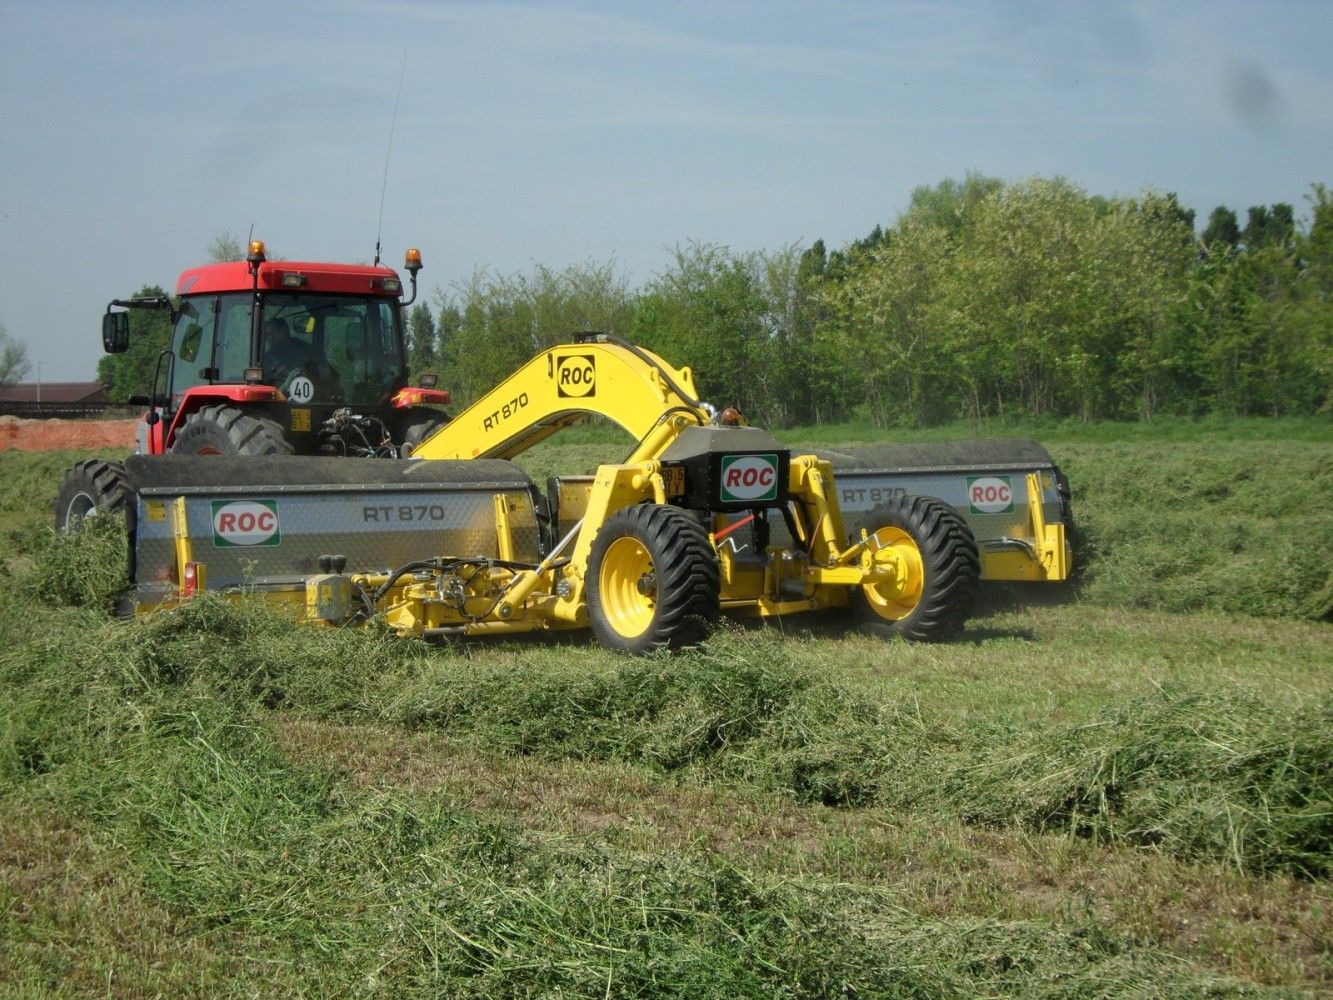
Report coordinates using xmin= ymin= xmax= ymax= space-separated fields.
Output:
xmin=0 ymin=637 xmax=1301 ymax=997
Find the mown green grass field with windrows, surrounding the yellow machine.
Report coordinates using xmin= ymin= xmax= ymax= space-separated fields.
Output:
xmin=0 ymin=421 xmax=1333 ymax=997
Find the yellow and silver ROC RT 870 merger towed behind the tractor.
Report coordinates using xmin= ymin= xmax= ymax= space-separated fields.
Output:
xmin=91 ymin=335 xmax=1070 ymax=652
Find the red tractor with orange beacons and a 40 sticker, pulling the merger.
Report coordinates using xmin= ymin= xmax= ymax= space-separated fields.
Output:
xmin=56 ymin=240 xmax=449 ymax=528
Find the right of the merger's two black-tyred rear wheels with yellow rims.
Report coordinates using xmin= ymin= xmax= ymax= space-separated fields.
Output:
xmin=852 ymin=496 xmax=981 ymax=641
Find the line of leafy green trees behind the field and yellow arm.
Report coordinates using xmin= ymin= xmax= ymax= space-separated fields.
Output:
xmin=99 ymin=175 xmax=1333 ymax=427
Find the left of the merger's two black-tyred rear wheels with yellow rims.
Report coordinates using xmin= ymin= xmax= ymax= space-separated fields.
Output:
xmin=587 ymin=504 xmax=721 ymax=653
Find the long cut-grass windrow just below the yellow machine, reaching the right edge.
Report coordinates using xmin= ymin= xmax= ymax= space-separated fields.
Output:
xmin=5 ymin=599 xmax=1333 ymax=877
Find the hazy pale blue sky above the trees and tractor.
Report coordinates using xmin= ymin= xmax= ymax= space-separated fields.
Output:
xmin=0 ymin=0 xmax=1333 ymax=381
